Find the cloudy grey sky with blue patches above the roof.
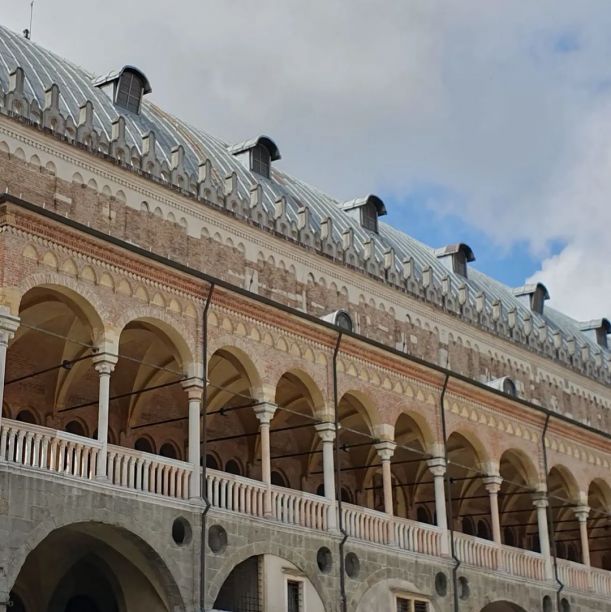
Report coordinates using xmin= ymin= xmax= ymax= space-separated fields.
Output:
xmin=0 ymin=0 xmax=611 ymax=320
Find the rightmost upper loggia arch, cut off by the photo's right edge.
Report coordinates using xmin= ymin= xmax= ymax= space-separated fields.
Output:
xmin=586 ymin=479 xmax=611 ymax=570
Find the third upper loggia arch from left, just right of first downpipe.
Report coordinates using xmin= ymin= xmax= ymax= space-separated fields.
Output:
xmin=206 ymin=347 xmax=261 ymax=478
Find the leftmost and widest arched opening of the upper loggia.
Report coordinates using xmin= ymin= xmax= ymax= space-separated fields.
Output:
xmin=3 ymin=285 xmax=102 ymax=436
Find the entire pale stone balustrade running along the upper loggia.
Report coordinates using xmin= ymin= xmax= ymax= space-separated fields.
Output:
xmin=0 ymin=419 xmax=611 ymax=596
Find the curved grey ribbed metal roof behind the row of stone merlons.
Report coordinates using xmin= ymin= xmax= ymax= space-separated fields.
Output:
xmin=0 ymin=26 xmax=609 ymax=378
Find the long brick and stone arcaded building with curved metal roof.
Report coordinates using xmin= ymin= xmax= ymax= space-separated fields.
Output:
xmin=0 ymin=21 xmax=611 ymax=612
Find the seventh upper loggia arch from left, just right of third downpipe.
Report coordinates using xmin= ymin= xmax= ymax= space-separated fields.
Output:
xmin=447 ymin=432 xmax=490 ymax=539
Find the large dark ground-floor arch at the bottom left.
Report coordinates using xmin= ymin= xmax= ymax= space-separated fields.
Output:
xmin=10 ymin=522 xmax=184 ymax=612
